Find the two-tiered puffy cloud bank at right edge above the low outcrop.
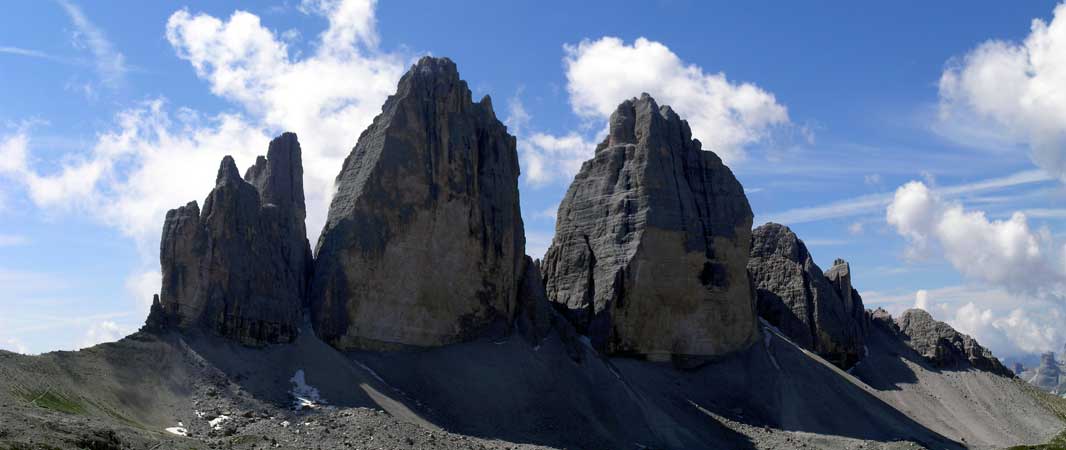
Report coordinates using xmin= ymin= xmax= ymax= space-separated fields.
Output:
xmin=886 ymin=181 xmax=1066 ymax=356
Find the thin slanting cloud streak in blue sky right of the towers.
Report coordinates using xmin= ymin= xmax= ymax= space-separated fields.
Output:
xmin=759 ymin=171 xmax=1053 ymax=225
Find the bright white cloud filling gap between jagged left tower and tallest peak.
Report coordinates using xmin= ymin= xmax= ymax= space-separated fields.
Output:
xmin=166 ymin=0 xmax=405 ymax=237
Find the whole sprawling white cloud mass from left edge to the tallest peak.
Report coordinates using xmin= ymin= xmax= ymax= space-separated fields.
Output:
xmin=0 ymin=0 xmax=404 ymax=249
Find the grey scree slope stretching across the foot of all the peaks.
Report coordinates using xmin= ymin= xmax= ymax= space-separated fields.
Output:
xmin=0 ymin=319 xmax=1062 ymax=449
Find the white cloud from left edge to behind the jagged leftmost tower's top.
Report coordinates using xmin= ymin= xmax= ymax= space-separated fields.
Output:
xmin=0 ymin=99 xmax=269 ymax=246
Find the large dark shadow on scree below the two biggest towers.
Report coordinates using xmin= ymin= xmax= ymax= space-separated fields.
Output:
xmin=350 ymin=322 xmax=962 ymax=449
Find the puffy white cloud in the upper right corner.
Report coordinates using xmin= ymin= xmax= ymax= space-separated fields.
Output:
xmin=939 ymin=4 xmax=1066 ymax=180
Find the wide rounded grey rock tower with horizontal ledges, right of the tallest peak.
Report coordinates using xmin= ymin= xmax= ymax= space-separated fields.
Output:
xmin=544 ymin=94 xmax=758 ymax=360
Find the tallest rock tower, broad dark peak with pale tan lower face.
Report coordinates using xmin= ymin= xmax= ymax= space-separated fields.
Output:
xmin=311 ymin=58 xmax=526 ymax=349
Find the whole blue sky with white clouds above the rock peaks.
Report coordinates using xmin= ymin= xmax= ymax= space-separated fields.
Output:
xmin=0 ymin=0 xmax=1066 ymax=356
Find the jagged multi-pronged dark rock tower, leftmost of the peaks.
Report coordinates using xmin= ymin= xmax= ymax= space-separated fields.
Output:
xmin=148 ymin=133 xmax=311 ymax=345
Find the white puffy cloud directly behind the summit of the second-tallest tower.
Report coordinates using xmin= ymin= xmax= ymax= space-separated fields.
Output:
xmin=564 ymin=36 xmax=789 ymax=162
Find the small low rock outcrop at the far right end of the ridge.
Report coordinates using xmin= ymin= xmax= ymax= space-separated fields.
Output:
xmin=895 ymin=309 xmax=1014 ymax=377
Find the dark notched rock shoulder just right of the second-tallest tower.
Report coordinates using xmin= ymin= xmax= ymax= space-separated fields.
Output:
xmin=747 ymin=223 xmax=867 ymax=368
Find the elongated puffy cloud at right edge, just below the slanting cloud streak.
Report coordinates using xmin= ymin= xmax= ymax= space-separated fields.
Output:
xmin=886 ymin=181 xmax=1066 ymax=294
